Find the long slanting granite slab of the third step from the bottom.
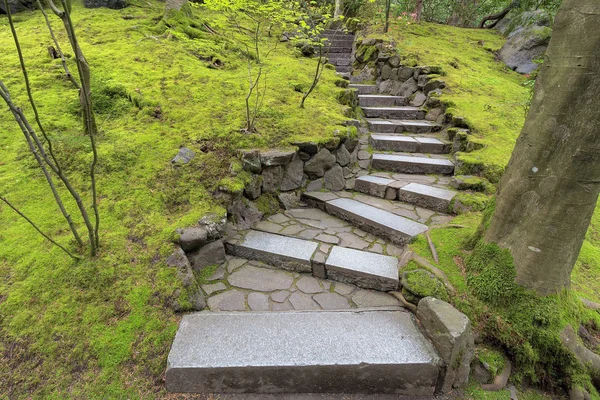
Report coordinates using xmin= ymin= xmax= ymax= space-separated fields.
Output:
xmin=325 ymin=199 xmax=427 ymax=245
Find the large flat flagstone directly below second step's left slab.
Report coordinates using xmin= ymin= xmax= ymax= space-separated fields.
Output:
xmin=227 ymin=265 xmax=294 ymax=292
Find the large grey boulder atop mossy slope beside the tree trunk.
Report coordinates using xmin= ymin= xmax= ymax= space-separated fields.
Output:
xmin=498 ymin=26 xmax=552 ymax=74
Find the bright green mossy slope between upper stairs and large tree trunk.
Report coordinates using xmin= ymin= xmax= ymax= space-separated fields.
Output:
xmin=372 ymin=21 xmax=529 ymax=183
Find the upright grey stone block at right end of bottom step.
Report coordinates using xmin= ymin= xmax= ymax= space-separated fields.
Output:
xmin=417 ymin=297 xmax=475 ymax=393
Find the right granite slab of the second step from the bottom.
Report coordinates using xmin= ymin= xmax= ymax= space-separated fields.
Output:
xmin=325 ymin=246 xmax=399 ymax=292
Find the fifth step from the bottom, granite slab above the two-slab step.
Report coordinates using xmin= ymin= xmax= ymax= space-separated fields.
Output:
xmin=371 ymin=153 xmax=454 ymax=175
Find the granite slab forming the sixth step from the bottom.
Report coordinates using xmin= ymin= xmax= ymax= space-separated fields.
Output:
xmin=370 ymin=134 xmax=450 ymax=154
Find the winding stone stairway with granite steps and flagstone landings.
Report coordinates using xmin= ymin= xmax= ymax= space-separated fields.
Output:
xmin=166 ymin=31 xmax=468 ymax=398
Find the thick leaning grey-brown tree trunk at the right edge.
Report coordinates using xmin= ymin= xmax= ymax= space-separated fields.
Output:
xmin=485 ymin=0 xmax=600 ymax=295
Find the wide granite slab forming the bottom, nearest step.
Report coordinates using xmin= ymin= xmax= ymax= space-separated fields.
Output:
xmin=166 ymin=309 xmax=441 ymax=396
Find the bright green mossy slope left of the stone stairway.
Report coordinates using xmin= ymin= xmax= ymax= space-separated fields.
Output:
xmin=0 ymin=0 xmax=344 ymax=398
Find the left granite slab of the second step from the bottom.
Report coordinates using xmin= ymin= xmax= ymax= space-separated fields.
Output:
xmin=227 ymin=231 xmax=319 ymax=272
